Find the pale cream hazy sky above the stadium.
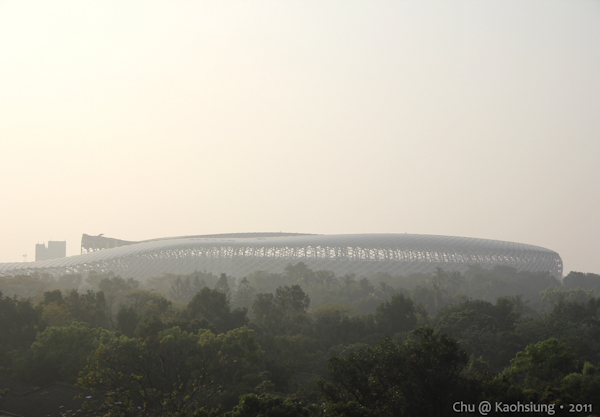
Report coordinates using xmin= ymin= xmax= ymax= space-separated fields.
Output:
xmin=0 ymin=0 xmax=600 ymax=274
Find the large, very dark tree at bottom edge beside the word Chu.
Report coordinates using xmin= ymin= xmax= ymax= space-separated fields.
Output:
xmin=319 ymin=328 xmax=476 ymax=416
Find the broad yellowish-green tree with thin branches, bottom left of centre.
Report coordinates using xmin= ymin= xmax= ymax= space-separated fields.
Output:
xmin=78 ymin=327 xmax=262 ymax=415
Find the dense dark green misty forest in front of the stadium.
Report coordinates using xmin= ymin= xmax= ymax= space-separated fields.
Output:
xmin=0 ymin=263 xmax=600 ymax=417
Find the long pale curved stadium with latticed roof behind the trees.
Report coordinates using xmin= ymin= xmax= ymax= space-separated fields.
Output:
xmin=0 ymin=233 xmax=562 ymax=280
